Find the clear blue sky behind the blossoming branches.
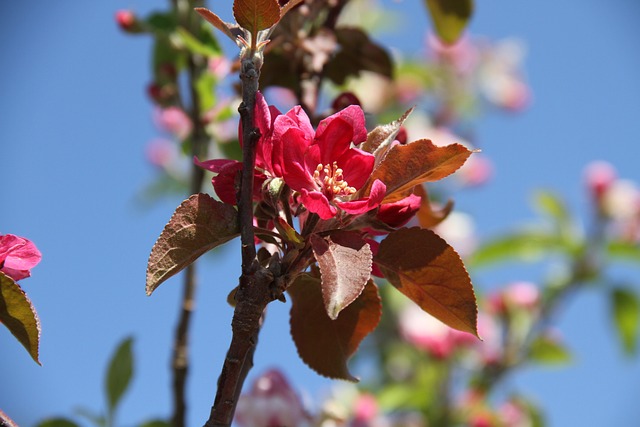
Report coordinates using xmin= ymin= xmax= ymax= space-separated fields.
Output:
xmin=0 ymin=0 xmax=640 ymax=427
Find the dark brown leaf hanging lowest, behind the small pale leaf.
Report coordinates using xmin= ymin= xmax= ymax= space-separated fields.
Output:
xmin=288 ymin=274 xmax=382 ymax=381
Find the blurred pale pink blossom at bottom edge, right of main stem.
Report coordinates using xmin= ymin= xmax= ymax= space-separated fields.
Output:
xmin=236 ymin=369 xmax=309 ymax=427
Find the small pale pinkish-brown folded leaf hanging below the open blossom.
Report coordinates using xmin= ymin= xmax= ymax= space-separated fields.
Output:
xmin=310 ymin=232 xmax=372 ymax=320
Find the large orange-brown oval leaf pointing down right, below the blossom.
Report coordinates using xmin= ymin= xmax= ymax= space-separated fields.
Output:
xmin=374 ymin=227 xmax=478 ymax=336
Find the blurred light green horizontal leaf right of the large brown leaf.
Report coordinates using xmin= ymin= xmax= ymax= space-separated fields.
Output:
xmin=467 ymin=231 xmax=561 ymax=267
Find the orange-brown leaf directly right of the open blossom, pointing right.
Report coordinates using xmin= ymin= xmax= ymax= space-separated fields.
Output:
xmin=364 ymin=139 xmax=471 ymax=203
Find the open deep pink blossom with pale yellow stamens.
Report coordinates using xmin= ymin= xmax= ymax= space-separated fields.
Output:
xmin=264 ymin=105 xmax=386 ymax=220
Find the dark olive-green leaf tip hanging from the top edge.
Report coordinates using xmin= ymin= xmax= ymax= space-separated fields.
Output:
xmin=426 ymin=0 xmax=473 ymax=44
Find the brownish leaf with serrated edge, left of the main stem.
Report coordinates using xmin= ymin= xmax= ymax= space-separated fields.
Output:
xmin=146 ymin=193 xmax=239 ymax=295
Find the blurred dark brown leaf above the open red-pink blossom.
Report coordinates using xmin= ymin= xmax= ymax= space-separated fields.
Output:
xmin=318 ymin=27 xmax=393 ymax=85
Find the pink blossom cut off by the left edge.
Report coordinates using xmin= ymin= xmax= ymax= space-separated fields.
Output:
xmin=0 ymin=234 xmax=42 ymax=281
